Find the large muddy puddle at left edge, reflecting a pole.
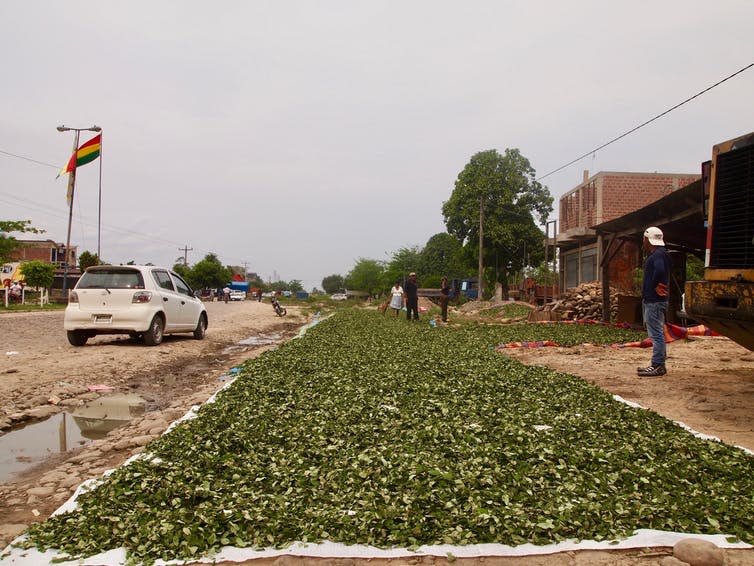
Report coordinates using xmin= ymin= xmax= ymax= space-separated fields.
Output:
xmin=0 ymin=394 xmax=146 ymax=483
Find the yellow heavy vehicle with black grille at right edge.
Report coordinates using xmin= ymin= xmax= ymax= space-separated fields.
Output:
xmin=685 ymin=132 xmax=754 ymax=351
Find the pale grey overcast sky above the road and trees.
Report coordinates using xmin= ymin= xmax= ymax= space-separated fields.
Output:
xmin=0 ymin=0 xmax=754 ymax=289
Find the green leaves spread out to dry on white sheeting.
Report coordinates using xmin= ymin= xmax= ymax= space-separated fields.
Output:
xmin=29 ymin=309 xmax=754 ymax=562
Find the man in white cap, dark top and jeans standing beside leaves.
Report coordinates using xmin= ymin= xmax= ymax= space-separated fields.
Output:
xmin=637 ymin=226 xmax=671 ymax=377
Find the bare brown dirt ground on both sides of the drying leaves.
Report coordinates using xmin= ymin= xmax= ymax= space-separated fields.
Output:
xmin=0 ymin=301 xmax=754 ymax=566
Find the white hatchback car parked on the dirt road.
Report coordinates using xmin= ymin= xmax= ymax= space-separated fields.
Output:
xmin=63 ymin=265 xmax=207 ymax=346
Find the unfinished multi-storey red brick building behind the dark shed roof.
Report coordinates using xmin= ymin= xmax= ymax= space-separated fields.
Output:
xmin=556 ymin=171 xmax=700 ymax=292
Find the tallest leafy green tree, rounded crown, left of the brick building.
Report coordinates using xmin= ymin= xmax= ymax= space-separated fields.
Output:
xmin=442 ymin=149 xmax=553 ymax=300
